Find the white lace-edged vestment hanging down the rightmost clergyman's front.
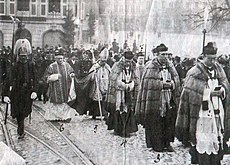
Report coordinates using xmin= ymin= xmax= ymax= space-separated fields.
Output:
xmin=196 ymin=79 xmax=224 ymax=155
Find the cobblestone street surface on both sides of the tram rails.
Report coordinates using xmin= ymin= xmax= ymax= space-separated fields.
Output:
xmin=0 ymin=101 xmax=230 ymax=165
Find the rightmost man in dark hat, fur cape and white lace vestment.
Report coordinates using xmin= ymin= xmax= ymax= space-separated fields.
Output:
xmin=176 ymin=42 xmax=229 ymax=165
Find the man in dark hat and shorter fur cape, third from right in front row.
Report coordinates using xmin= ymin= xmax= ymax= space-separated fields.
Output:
xmin=107 ymin=51 xmax=138 ymax=137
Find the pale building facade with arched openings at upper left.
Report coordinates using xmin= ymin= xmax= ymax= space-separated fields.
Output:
xmin=0 ymin=0 xmax=86 ymax=48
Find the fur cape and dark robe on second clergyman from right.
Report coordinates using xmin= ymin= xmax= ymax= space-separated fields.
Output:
xmin=135 ymin=59 xmax=180 ymax=150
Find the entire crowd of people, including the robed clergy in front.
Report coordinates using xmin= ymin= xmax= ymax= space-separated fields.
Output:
xmin=0 ymin=40 xmax=230 ymax=165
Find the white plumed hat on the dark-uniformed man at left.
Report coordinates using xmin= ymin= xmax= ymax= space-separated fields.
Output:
xmin=14 ymin=39 xmax=32 ymax=61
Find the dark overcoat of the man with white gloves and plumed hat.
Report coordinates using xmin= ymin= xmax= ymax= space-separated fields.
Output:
xmin=4 ymin=62 xmax=36 ymax=118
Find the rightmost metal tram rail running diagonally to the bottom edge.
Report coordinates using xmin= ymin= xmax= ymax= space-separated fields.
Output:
xmin=33 ymin=105 xmax=95 ymax=165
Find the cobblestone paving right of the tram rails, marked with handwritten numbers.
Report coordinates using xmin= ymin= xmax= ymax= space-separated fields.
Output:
xmin=35 ymin=102 xmax=230 ymax=165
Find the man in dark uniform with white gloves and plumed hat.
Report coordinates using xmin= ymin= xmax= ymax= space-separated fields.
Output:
xmin=3 ymin=43 xmax=37 ymax=139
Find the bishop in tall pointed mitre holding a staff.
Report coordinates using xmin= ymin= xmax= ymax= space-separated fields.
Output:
xmin=89 ymin=48 xmax=111 ymax=119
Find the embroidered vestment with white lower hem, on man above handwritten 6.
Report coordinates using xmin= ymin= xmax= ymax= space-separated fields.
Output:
xmin=44 ymin=62 xmax=73 ymax=120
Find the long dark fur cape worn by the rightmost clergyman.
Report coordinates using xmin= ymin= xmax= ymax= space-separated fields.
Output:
xmin=176 ymin=63 xmax=230 ymax=164
